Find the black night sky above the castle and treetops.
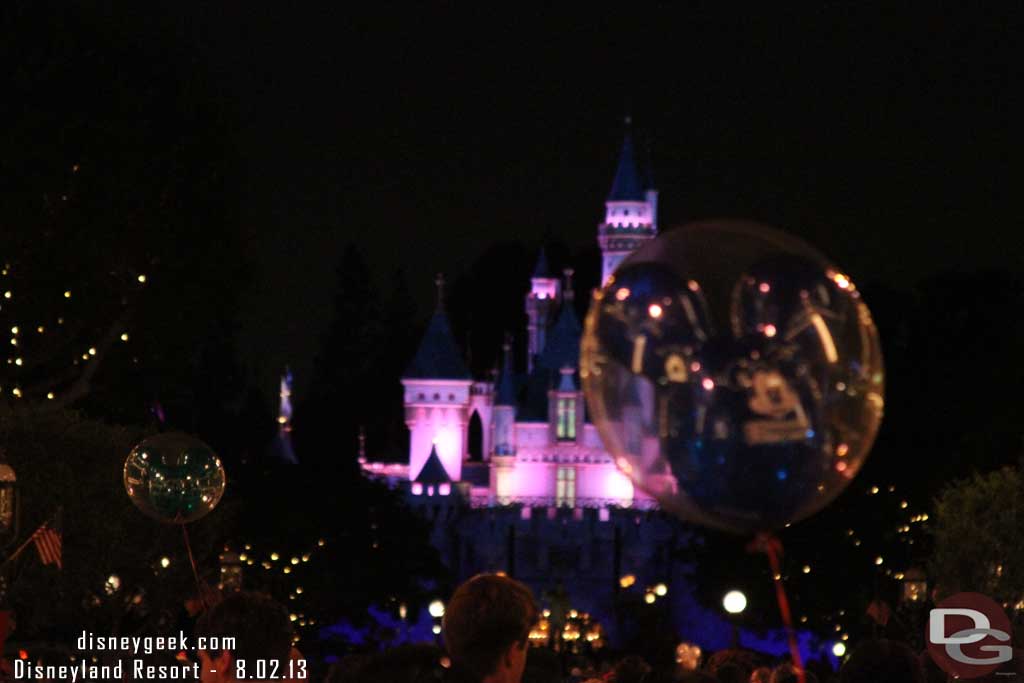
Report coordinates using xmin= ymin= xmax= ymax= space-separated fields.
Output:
xmin=90 ymin=3 xmax=1024 ymax=397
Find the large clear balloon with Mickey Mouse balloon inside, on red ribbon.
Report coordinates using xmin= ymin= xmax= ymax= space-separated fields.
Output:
xmin=581 ymin=221 xmax=884 ymax=532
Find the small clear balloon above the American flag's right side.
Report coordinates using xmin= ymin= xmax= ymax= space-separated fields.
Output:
xmin=124 ymin=432 xmax=225 ymax=524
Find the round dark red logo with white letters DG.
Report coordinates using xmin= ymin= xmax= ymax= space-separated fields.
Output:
xmin=926 ymin=593 xmax=1013 ymax=678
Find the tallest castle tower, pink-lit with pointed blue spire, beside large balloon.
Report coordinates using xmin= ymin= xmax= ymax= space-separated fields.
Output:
xmin=597 ymin=117 xmax=657 ymax=287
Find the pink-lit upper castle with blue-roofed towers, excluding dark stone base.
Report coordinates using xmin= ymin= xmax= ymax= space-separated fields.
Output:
xmin=362 ymin=120 xmax=657 ymax=511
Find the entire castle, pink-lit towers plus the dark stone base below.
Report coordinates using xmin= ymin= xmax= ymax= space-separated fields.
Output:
xmin=360 ymin=120 xmax=728 ymax=651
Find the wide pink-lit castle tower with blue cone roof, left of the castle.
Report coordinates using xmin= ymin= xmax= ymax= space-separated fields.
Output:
xmin=401 ymin=275 xmax=473 ymax=481
